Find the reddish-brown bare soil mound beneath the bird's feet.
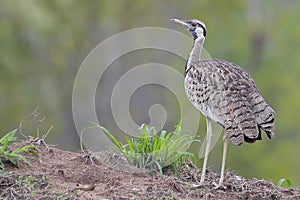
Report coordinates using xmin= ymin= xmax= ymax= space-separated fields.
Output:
xmin=0 ymin=141 xmax=300 ymax=200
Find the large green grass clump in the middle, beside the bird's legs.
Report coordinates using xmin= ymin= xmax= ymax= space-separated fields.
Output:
xmin=82 ymin=121 xmax=198 ymax=175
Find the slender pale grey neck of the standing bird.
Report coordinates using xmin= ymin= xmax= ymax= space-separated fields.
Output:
xmin=185 ymin=37 xmax=205 ymax=73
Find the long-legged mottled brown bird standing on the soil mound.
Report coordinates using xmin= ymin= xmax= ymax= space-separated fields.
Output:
xmin=171 ymin=18 xmax=275 ymax=188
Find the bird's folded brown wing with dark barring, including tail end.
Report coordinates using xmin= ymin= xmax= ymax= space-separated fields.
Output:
xmin=200 ymin=59 xmax=274 ymax=145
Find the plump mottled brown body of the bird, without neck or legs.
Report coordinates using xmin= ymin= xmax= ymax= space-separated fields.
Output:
xmin=185 ymin=59 xmax=274 ymax=145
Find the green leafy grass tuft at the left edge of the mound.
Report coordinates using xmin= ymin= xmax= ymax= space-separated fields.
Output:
xmin=0 ymin=129 xmax=37 ymax=173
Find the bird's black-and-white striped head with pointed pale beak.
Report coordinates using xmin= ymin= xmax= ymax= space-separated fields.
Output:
xmin=171 ymin=19 xmax=206 ymax=40
